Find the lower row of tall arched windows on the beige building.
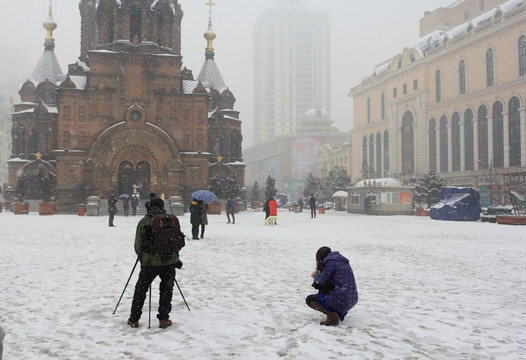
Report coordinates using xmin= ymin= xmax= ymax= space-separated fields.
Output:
xmin=362 ymin=96 xmax=524 ymax=176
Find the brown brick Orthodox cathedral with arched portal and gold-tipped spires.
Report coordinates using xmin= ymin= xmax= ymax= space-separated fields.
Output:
xmin=6 ymin=0 xmax=245 ymax=213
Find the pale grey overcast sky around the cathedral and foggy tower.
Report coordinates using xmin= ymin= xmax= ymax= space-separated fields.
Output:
xmin=0 ymin=0 xmax=454 ymax=148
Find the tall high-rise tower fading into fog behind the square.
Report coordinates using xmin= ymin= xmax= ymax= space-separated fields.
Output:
xmin=253 ymin=0 xmax=330 ymax=144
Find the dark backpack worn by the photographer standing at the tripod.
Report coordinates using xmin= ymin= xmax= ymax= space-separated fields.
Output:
xmin=151 ymin=214 xmax=185 ymax=261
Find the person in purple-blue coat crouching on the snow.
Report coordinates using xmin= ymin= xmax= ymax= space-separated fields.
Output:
xmin=305 ymin=246 xmax=358 ymax=326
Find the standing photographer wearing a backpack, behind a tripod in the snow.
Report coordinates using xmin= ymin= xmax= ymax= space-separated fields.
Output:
xmin=128 ymin=198 xmax=184 ymax=329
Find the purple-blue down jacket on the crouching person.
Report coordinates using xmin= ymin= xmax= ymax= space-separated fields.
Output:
xmin=314 ymin=251 xmax=358 ymax=314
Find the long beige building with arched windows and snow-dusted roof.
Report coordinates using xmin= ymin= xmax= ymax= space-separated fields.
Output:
xmin=349 ymin=0 xmax=526 ymax=205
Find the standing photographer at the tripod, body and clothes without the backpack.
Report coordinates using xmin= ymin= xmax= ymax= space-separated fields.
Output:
xmin=128 ymin=198 xmax=183 ymax=329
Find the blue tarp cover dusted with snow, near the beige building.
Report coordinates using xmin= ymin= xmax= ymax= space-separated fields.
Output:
xmin=430 ymin=186 xmax=480 ymax=221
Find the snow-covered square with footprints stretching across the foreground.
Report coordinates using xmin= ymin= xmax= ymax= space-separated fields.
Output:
xmin=0 ymin=211 xmax=526 ymax=360
